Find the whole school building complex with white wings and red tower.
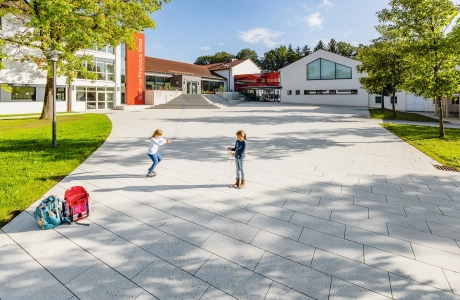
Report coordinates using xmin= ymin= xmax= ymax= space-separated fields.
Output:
xmin=0 ymin=17 xmax=459 ymax=116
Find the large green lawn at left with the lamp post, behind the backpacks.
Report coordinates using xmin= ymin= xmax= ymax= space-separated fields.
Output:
xmin=0 ymin=114 xmax=112 ymax=227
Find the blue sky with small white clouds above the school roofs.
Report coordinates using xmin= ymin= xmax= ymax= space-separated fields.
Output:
xmin=144 ymin=0 xmax=389 ymax=63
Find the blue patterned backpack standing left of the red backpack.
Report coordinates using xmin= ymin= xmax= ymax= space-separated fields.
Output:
xmin=34 ymin=196 xmax=70 ymax=229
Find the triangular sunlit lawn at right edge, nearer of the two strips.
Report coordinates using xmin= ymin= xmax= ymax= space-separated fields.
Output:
xmin=381 ymin=123 xmax=460 ymax=169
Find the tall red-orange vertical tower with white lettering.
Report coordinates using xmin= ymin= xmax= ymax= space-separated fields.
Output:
xmin=126 ymin=33 xmax=145 ymax=105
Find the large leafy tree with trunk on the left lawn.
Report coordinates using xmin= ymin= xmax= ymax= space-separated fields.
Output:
xmin=0 ymin=0 xmax=171 ymax=119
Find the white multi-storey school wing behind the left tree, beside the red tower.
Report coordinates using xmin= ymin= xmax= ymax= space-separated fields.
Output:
xmin=0 ymin=17 xmax=122 ymax=114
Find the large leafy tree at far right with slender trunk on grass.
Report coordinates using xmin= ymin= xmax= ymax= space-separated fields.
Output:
xmin=376 ymin=0 xmax=460 ymax=137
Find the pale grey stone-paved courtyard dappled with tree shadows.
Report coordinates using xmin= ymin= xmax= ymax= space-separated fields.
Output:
xmin=0 ymin=103 xmax=460 ymax=300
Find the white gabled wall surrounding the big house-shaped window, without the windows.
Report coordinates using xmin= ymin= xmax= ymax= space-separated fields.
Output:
xmin=280 ymin=50 xmax=369 ymax=106
